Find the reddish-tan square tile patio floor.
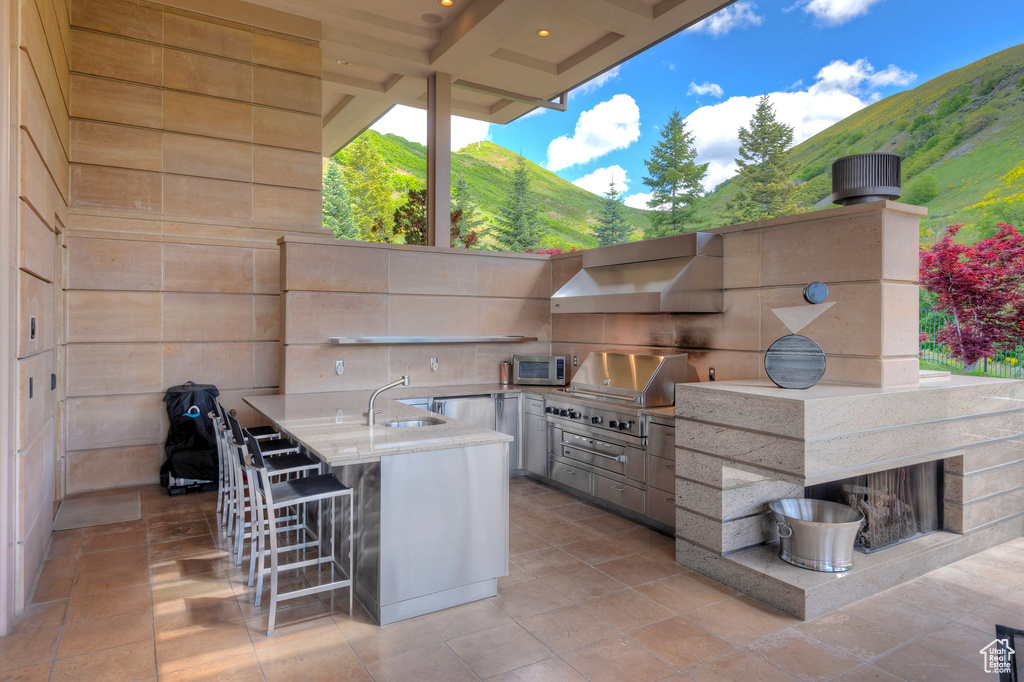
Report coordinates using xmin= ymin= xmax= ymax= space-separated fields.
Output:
xmin=0 ymin=479 xmax=1024 ymax=682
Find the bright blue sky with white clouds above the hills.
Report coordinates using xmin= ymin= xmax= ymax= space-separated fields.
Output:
xmin=374 ymin=0 xmax=1024 ymax=207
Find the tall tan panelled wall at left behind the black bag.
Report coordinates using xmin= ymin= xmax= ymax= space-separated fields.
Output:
xmin=67 ymin=0 xmax=323 ymax=492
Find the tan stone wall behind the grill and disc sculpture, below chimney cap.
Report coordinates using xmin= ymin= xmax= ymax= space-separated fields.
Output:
xmin=552 ymin=202 xmax=924 ymax=386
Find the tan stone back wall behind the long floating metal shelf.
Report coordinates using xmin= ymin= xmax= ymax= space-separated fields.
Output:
xmin=281 ymin=237 xmax=551 ymax=393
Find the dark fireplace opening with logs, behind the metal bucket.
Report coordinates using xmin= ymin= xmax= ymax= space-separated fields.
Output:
xmin=804 ymin=460 xmax=944 ymax=553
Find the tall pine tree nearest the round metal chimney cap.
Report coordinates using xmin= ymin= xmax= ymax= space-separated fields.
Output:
xmin=722 ymin=95 xmax=797 ymax=223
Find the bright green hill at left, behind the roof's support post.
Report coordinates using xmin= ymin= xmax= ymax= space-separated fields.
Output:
xmin=338 ymin=130 xmax=650 ymax=249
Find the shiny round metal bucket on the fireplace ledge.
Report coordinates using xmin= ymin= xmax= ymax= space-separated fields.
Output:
xmin=769 ymin=499 xmax=864 ymax=572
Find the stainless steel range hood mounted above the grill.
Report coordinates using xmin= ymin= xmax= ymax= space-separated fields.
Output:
xmin=551 ymin=232 xmax=723 ymax=312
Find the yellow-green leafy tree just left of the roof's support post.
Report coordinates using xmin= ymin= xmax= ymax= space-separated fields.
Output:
xmin=341 ymin=134 xmax=395 ymax=242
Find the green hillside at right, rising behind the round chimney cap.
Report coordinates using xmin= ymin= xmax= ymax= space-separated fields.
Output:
xmin=693 ymin=45 xmax=1024 ymax=241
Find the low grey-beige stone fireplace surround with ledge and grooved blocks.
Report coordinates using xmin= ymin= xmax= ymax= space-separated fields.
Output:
xmin=676 ymin=377 xmax=1024 ymax=619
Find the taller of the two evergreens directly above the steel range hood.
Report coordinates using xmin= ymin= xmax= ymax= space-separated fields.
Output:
xmin=643 ymin=110 xmax=708 ymax=237
